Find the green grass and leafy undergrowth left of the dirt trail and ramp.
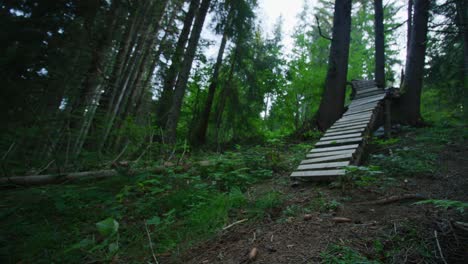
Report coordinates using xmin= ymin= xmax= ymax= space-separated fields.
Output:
xmin=0 ymin=142 xmax=310 ymax=263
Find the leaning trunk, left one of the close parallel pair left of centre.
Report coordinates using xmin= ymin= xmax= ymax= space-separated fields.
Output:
xmin=157 ymin=0 xmax=200 ymax=127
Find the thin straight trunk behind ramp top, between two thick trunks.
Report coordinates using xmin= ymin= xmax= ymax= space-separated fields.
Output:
xmin=374 ymin=0 xmax=385 ymax=88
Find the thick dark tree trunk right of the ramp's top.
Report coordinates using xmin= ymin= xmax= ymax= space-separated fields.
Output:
xmin=400 ymin=0 xmax=430 ymax=125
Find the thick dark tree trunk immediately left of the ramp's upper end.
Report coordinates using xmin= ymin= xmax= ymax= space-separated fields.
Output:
xmin=317 ymin=0 xmax=352 ymax=130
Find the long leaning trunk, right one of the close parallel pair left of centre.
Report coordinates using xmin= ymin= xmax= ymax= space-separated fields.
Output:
xmin=165 ymin=0 xmax=211 ymax=144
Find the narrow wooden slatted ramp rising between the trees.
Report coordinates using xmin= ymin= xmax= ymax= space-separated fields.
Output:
xmin=291 ymin=81 xmax=385 ymax=180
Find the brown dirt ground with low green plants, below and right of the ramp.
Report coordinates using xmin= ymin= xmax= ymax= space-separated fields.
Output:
xmin=178 ymin=125 xmax=468 ymax=264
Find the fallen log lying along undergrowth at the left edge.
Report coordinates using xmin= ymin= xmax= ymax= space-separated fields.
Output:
xmin=0 ymin=170 xmax=119 ymax=186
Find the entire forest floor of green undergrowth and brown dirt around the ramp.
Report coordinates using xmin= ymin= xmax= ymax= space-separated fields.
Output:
xmin=0 ymin=122 xmax=468 ymax=264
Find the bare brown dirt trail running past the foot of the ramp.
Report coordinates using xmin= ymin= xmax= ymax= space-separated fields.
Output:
xmin=176 ymin=141 xmax=468 ymax=264
